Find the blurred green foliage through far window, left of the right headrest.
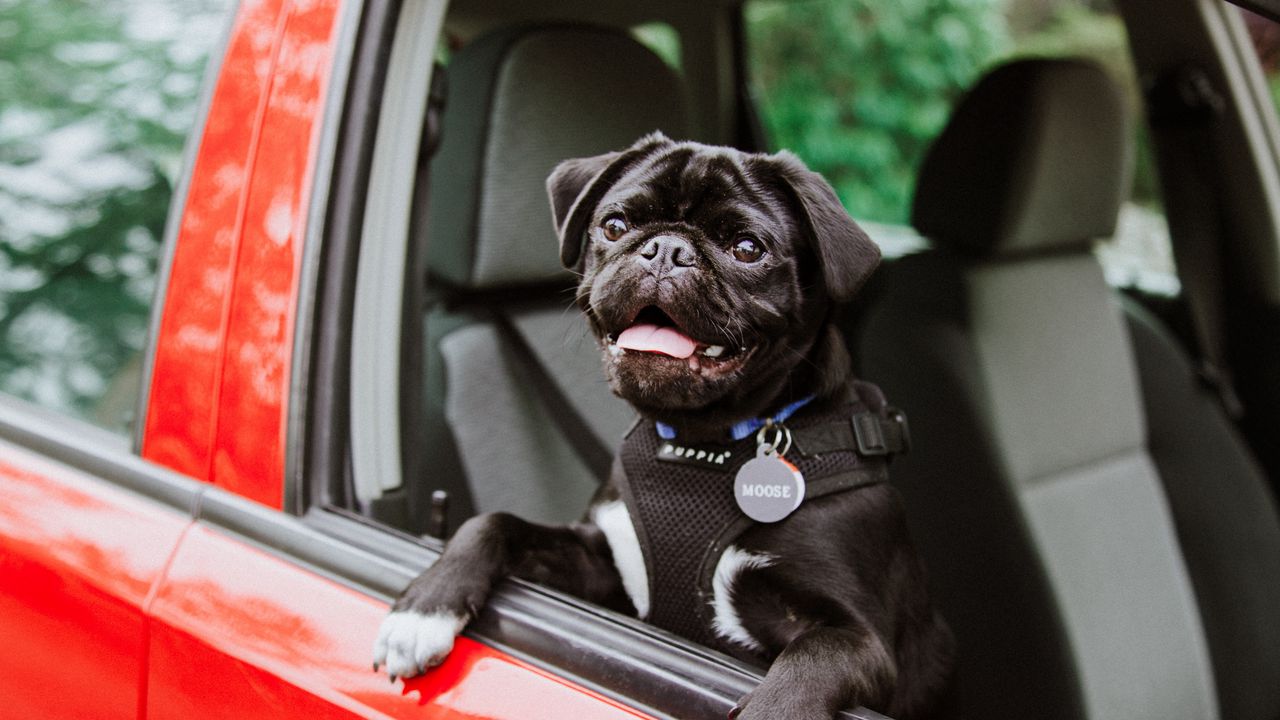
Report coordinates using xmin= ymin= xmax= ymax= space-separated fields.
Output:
xmin=745 ymin=0 xmax=1009 ymax=223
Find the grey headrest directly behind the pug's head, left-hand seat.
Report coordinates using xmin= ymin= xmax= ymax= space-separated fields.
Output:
xmin=426 ymin=26 xmax=687 ymax=290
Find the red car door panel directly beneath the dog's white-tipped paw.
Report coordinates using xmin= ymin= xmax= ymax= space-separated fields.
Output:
xmin=147 ymin=493 xmax=645 ymax=720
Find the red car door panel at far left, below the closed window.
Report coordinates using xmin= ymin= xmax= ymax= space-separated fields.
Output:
xmin=0 ymin=412 xmax=196 ymax=719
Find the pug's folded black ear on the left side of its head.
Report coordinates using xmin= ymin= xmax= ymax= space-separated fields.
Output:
xmin=547 ymin=132 xmax=672 ymax=268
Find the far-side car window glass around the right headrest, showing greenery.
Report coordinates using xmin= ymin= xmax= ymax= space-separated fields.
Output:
xmin=744 ymin=0 xmax=1178 ymax=293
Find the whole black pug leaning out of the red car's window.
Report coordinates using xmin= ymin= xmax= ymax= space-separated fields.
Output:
xmin=375 ymin=133 xmax=952 ymax=720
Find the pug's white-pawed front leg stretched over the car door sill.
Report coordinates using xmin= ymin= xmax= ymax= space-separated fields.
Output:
xmin=374 ymin=512 xmax=625 ymax=678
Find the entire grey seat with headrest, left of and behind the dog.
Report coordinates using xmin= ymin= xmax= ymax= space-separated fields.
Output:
xmin=422 ymin=26 xmax=687 ymax=528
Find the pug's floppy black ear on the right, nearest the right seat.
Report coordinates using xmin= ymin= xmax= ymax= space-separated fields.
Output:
xmin=773 ymin=151 xmax=881 ymax=302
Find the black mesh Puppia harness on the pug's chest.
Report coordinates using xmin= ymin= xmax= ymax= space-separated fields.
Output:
xmin=618 ymin=382 xmax=909 ymax=652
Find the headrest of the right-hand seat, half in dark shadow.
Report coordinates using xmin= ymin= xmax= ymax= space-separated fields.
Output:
xmin=911 ymin=59 xmax=1132 ymax=256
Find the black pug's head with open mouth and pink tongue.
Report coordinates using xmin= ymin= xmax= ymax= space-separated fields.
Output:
xmin=547 ymin=133 xmax=879 ymax=438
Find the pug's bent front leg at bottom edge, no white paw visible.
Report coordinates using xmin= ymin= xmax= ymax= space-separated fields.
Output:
xmin=730 ymin=626 xmax=897 ymax=720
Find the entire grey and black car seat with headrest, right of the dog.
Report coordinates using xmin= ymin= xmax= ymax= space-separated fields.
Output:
xmin=855 ymin=60 xmax=1280 ymax=720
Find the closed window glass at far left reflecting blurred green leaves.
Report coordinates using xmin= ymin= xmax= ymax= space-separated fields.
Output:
xmin=0 ymin=0 xmax=230 ymax=433
